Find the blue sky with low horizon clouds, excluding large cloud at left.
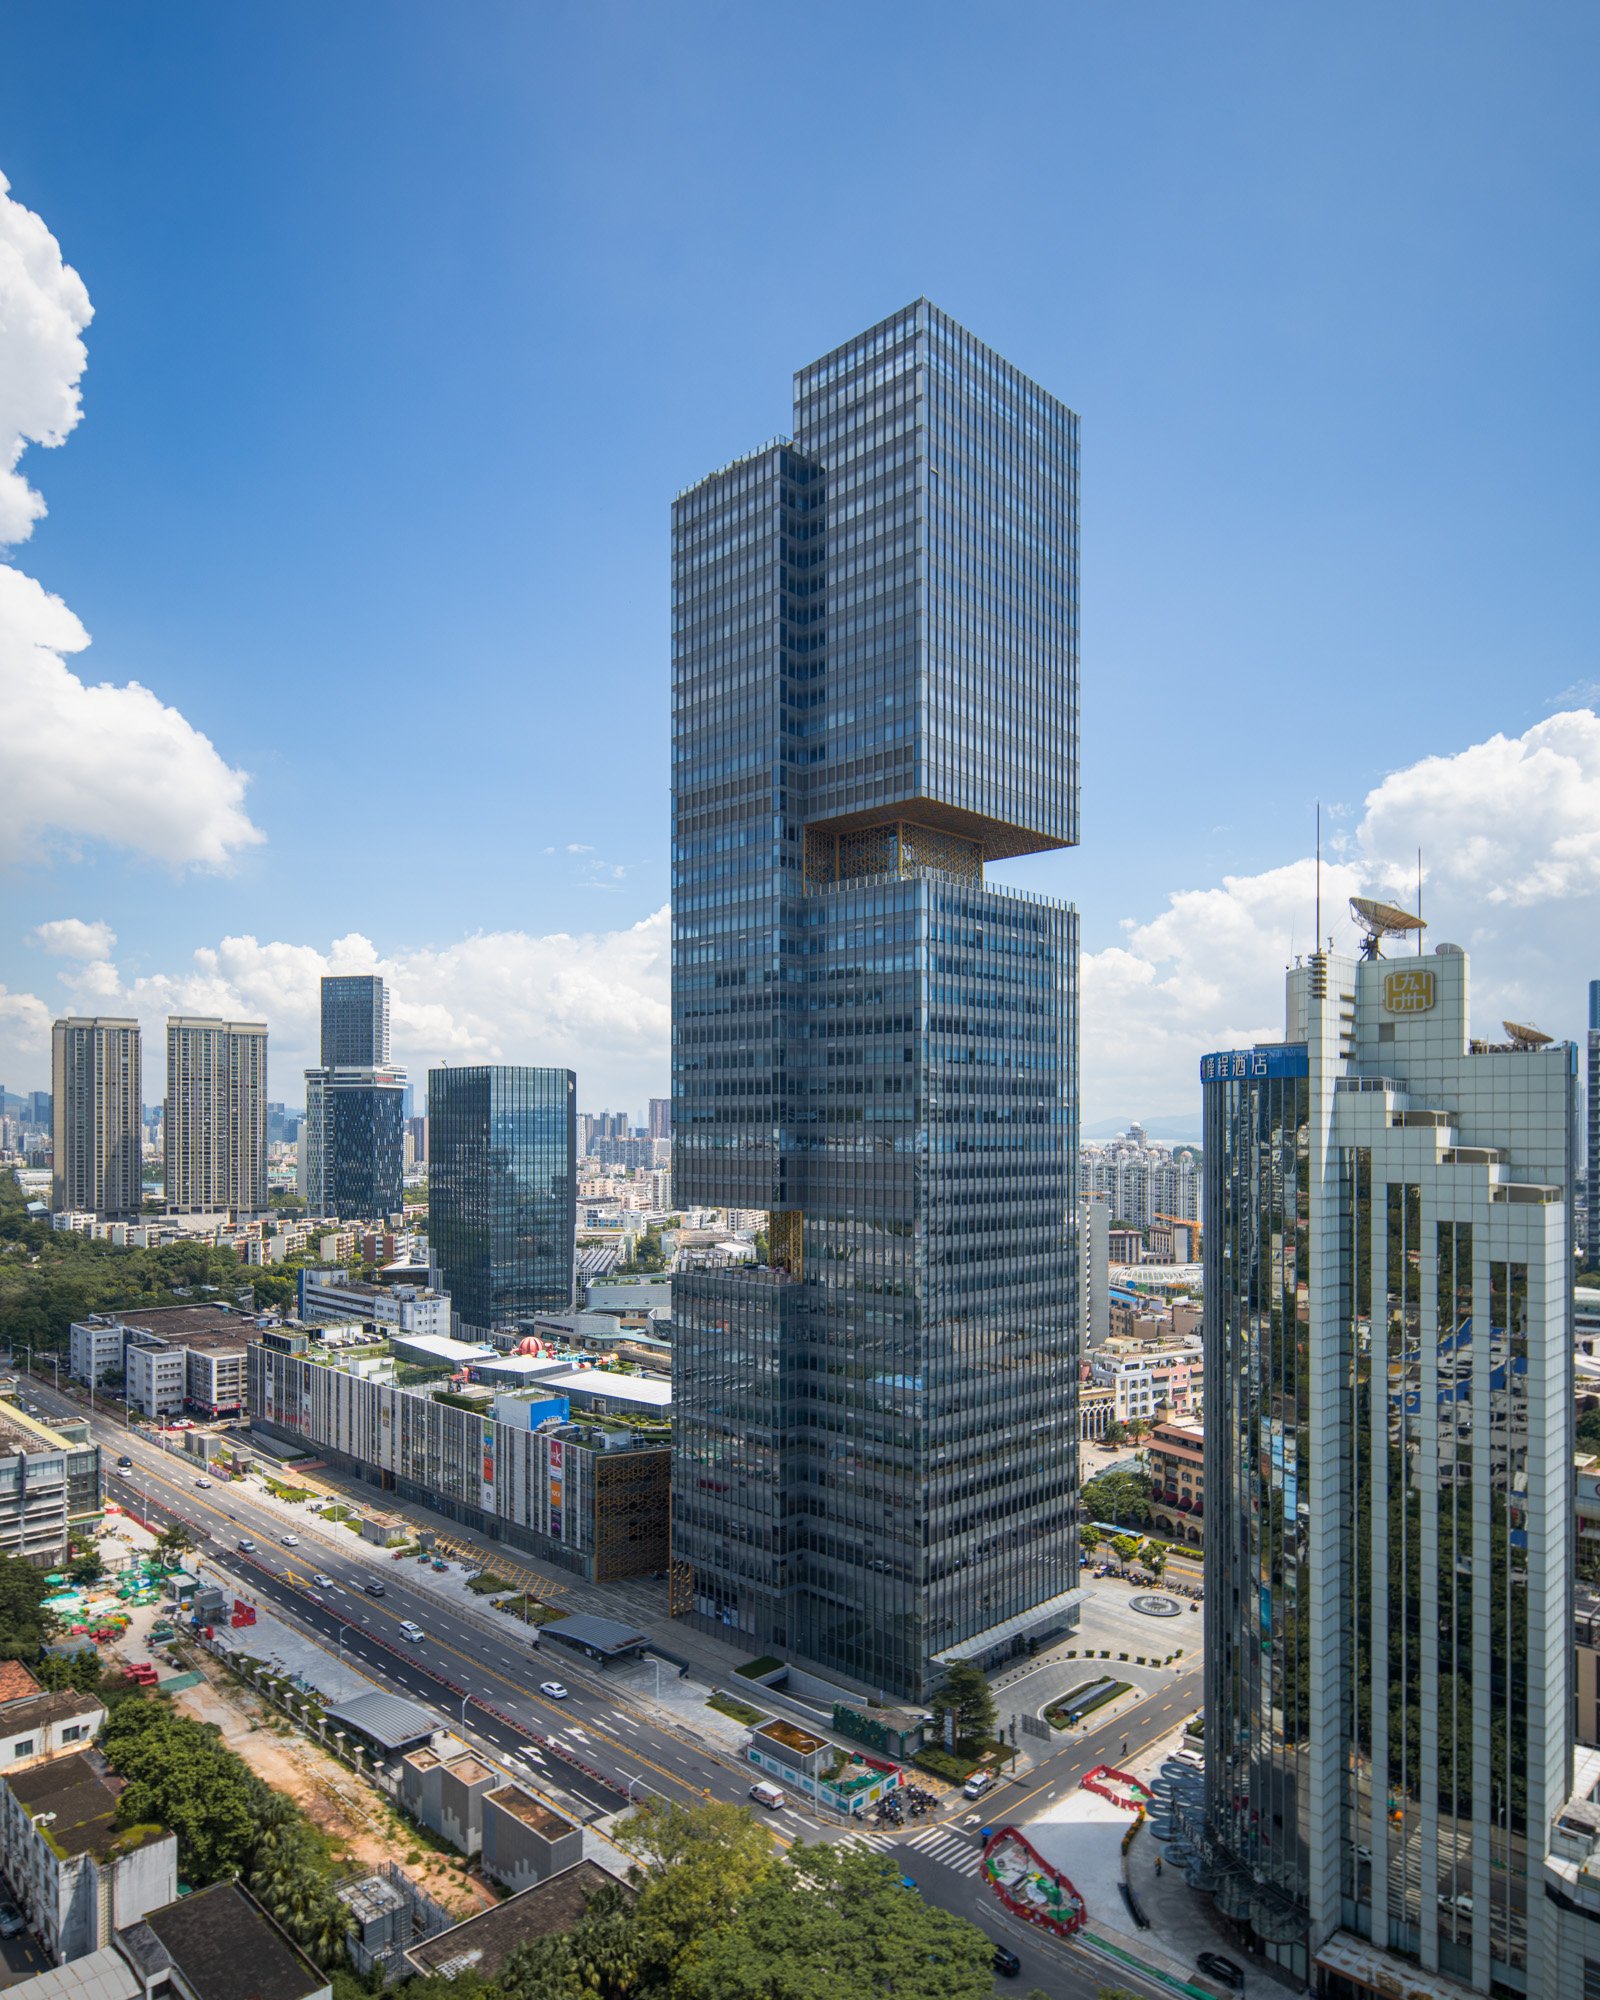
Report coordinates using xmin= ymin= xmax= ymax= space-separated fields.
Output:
xmin=0 ymin=0 xmax=1600 ymax=1122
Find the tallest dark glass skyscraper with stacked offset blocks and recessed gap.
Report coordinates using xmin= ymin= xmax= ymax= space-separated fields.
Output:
xmin=672 ymin=300 xmax=1078 ymax=1696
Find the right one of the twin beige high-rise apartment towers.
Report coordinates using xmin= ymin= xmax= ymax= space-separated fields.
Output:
xmin=164 ymin=1014 xmax=268 ymax=1216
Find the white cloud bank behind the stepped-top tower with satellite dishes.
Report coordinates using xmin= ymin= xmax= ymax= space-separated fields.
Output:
xmin=1082 ymin=708 xmax=1600 ymax=1132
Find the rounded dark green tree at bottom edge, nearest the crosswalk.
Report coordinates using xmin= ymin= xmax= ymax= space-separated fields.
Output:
xmin=672 ymin=1844 xmax=994 ymax=2000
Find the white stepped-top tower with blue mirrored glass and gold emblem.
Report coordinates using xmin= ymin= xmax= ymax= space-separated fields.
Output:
xmin=1188 ymin=946 xmax=1576 ymax=2000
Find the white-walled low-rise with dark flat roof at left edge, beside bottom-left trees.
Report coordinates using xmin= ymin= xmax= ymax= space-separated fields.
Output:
xmin=0 ymin=1750 xmax=178 ymax=1966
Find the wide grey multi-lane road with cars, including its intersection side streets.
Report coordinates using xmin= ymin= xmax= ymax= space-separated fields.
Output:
xmin=26 ymin=1384 xmax=1198 ymax=2000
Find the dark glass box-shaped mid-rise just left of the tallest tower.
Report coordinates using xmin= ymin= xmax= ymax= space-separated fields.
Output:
xmin=428 ymin=1066 xmax=578 ymax=1338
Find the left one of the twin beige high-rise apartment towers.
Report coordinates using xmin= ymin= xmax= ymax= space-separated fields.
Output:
xmin=50 ymin=1014 xmax=144 ymax=1220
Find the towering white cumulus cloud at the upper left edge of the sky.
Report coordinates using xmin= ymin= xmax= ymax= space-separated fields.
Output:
xmin=0 ymin=164 xmax=264 ymax=868
